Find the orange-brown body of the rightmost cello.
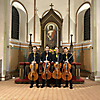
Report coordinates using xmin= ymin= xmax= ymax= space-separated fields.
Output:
xmin=62 ymin=63 xmax=72 ymax=81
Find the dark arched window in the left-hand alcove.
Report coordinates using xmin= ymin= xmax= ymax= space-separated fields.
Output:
xmin=11 ymin=6 xmax=19 ymax=40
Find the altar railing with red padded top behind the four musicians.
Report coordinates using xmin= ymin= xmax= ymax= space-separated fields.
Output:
xmin=19 ymin=62 xmax=81 ymax=79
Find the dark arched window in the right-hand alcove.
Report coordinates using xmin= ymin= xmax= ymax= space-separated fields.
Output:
xmin=84 ymin=8 xmax=90 ymax=41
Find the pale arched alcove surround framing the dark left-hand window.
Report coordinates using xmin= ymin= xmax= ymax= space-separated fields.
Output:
xmin=10 ymin=1 xmax=28 ymax=42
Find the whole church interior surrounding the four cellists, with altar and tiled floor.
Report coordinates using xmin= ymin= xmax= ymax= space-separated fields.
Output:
xmin=0 ymin=0 xmax=100 ymax=100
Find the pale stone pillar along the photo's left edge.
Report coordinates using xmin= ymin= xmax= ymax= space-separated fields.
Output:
xmin=0 ymin=0 xmax=10 ymax=80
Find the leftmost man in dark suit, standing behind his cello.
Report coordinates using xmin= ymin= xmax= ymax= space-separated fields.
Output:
xmin=28 ymin=46 xmax=40 ymax=88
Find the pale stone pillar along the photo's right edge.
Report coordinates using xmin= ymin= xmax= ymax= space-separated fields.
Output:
xmin=90 ymin=0 xmax=100 ymax=81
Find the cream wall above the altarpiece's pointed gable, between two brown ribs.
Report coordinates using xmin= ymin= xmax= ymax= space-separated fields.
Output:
xmin=36 ymin=0 xmax=67 ymax=18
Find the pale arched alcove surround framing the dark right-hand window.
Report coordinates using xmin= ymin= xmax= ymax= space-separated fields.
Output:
xmin=76 ymin=3 xmax=91 ymax=43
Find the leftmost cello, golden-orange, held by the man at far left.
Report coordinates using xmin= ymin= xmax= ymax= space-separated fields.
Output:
xmin=28 ymin=55 xmax=38 ymax=81
